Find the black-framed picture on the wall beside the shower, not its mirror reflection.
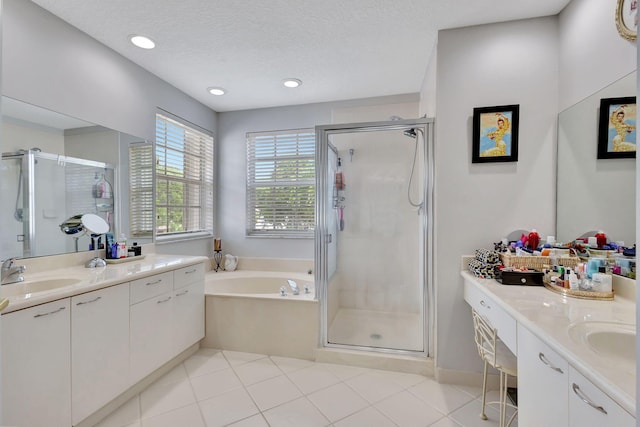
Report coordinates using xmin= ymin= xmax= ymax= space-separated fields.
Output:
xmin=471 ymin=105 xmax=520 ymax=163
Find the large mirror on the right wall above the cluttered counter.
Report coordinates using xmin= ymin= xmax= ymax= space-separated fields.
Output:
xmin=556 ymin=72 xmax=636 ymax=246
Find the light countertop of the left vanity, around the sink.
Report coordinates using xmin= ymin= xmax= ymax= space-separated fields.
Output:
xmin=0 ymin=254 xmax=209 ymax=315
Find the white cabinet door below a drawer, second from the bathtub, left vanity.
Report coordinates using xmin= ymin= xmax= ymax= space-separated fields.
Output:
xmin=130 ymin=291 xmax=173 ymax=382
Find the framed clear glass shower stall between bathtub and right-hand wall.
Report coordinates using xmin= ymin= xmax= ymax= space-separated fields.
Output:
xmin=315 ymin=119 xmax=433 ymax=354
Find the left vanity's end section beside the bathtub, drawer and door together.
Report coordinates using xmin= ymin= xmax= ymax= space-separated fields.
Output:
xmin=172 ymin=264 xmax=204 ymax=354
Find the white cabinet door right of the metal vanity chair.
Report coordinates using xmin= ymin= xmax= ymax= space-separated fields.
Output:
xmin=518 ymin=325 xmax=569 ymax=426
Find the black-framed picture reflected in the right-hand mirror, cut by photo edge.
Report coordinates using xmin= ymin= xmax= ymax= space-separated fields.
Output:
xmin=598 ymin=96 xmax=637 ymax=159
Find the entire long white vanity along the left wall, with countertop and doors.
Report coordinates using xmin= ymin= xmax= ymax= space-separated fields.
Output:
xmin=0 ymin=254 xmax=207 ymax=427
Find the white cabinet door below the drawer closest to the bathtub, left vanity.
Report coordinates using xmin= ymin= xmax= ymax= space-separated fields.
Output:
xmin=173 ymin=281 xmax=204 ymax=354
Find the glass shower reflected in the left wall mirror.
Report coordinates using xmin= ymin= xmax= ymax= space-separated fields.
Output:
xmin=0 ymin=149 xmax=115 ymax=257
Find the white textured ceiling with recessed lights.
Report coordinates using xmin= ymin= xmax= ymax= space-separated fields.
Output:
xmin=32 ymin=0 xmax=569 ymax=111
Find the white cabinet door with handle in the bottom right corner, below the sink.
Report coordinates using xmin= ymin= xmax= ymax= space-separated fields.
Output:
xmin=569 ymin=368 xmax=636 ymax=427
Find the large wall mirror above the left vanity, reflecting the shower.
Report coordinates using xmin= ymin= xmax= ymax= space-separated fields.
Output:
xmin=0 ymin=97 xmax=151 ymax=260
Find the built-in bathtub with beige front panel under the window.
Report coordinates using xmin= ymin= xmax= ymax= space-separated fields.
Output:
xmin=202 ymin=270 xmax=320 ymax=360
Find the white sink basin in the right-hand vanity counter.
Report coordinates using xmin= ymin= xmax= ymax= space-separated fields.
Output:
xmin=569 ymin=321 xmax=636 ymax=370
